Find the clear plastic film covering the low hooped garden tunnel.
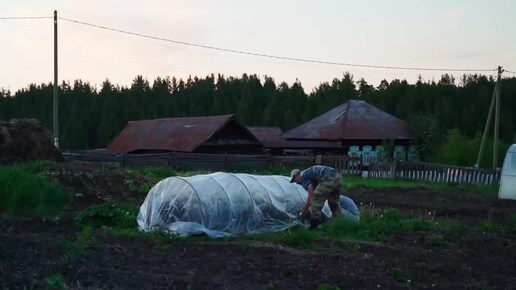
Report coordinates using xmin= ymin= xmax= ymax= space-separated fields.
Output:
xmin=137 ymin=172 xmax=360 ymax=238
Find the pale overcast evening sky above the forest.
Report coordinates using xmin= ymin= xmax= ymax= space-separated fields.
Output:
xmin=0 ymin=0 xmax=516 ymax=92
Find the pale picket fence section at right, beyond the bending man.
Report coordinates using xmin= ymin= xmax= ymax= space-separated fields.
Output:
xmin=368 ymin=162 xmax=501 ymax=186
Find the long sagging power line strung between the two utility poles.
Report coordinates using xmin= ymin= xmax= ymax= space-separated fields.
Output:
xmin=59 ymin=17 xmax=496 ymax=72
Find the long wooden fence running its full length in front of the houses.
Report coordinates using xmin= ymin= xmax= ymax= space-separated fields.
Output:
xmin=65 ymin=151 xmax=501 ymax=185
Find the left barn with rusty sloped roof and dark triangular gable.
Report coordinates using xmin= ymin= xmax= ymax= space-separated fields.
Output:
xmin=107 ymin=115 xmax=263 ymax=154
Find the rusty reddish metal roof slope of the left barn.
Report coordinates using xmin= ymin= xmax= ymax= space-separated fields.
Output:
xmin=107 ymin=115 xmax=256 ymax=153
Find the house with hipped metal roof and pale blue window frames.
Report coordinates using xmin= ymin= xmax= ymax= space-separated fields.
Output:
xmin=276 ymin=100 xmax=410 ymax=157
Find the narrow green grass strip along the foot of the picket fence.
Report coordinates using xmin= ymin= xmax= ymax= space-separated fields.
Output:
xmin=344 ymin=176 xmax=498 ymax=195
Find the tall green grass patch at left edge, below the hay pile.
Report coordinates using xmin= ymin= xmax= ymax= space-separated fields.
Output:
xmin=0 ymin=163 xmax=72 ymax=215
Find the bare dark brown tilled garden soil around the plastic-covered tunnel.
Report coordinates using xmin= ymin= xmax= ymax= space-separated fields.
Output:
xmin=0 ymin=163 xmax=516 ymax=289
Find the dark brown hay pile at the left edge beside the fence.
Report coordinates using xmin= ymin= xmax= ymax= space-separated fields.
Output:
xmin=0 ymin=119 xmax=63 ymax=164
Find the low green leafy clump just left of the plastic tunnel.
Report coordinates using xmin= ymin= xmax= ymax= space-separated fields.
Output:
xmin=75 ymin=201 xmax=138 ymax=228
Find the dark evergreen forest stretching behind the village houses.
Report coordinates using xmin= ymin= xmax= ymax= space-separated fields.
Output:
xmin=0 ymin=73 xmax=516 ymax=165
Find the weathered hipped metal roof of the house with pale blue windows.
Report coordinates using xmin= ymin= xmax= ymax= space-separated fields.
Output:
xmin=281 ymin=100 xmax=410 ymax=140
